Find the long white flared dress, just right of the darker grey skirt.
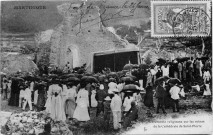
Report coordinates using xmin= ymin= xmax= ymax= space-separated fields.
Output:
xmin=73 ymin=88 xmax=90 ymax=121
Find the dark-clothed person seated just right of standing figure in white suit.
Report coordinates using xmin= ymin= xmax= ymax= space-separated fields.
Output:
xmin=123 ymin=101 xmax=138 ymax=129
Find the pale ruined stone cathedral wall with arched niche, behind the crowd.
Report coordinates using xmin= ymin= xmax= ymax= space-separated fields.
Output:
xmin=50 ymin=3 xmax=138 ymax=68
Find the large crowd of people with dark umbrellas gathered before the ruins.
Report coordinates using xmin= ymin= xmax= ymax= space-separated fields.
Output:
xmin=1 ymin=56 xmax=212 ymax=130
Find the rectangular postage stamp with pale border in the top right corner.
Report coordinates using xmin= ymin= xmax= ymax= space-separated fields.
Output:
xmin=151 ymin=1 xmax=211 ymax=37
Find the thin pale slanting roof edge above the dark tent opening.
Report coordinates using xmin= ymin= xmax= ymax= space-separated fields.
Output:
xmin=92 ymin=48 xmax=139 ymax=56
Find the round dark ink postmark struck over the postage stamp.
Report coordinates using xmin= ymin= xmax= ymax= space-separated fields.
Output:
xmin=170 ymin=7 xmax=211 ymax=46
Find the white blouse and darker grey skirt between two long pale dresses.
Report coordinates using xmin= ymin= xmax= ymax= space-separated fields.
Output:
xmin=65 ymin=87 xmax=77 ymax=118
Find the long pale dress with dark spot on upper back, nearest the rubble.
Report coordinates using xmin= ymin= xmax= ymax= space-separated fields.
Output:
xmin=49 ymin=84 xmax=66 ymax=121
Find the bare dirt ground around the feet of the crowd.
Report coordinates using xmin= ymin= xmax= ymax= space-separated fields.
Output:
xmin=1 ymin=96 xmax=212 ymax=135
